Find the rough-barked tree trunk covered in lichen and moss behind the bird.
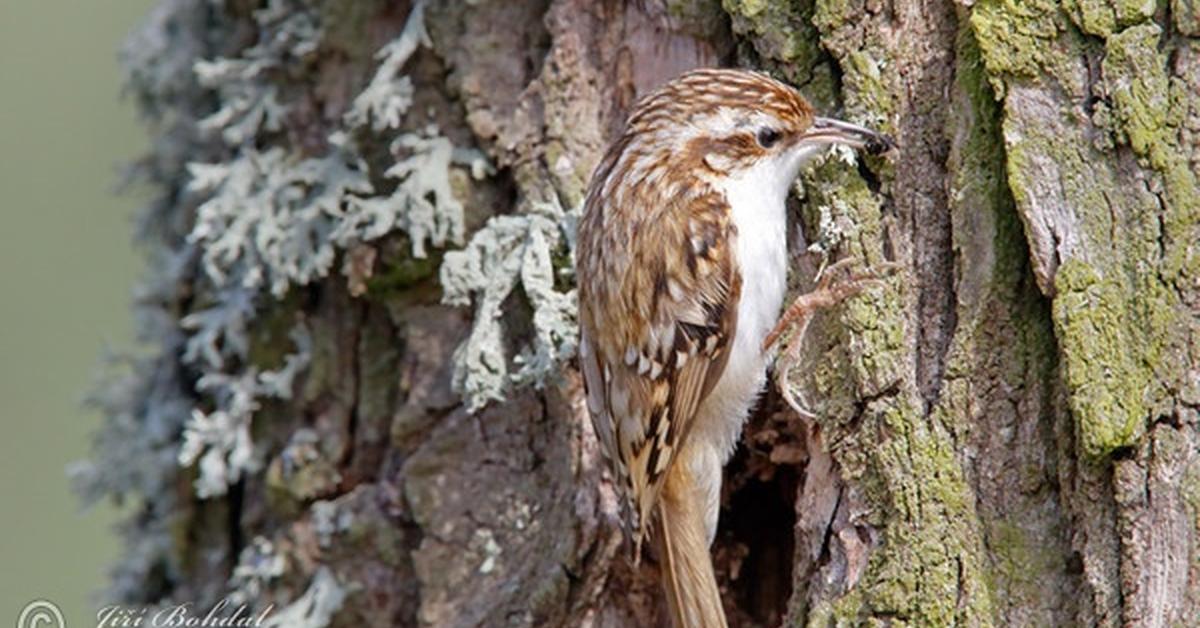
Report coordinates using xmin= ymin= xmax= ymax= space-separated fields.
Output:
xmin=88 ymin=0 xmax=1200 ymax=627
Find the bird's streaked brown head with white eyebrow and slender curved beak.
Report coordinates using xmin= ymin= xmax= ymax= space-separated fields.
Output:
xmin=604 ymin=70 xmax=895 ymax=204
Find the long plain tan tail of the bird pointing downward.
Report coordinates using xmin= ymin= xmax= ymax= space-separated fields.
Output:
xmin=653 ymin=461 xmax=728 ymax=628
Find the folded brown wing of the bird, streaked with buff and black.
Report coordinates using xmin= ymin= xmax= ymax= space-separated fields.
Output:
xmin=578 ymin=184 xmax=742 ymax=543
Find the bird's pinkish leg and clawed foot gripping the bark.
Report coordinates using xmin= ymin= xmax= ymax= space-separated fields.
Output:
xmin=762 ymin=258 xmax=900 ymax=418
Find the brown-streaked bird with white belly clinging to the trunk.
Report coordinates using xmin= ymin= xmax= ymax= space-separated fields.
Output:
xmin=575 ymin=68 xmax=895 ymax=628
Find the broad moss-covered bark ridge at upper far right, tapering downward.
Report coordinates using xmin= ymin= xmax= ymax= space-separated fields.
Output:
xmin=971 ymin=0 xmax=1200 ymax=461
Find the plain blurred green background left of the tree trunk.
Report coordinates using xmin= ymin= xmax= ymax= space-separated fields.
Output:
xmin=0 ymin=0 xmax=154 ymax=627
